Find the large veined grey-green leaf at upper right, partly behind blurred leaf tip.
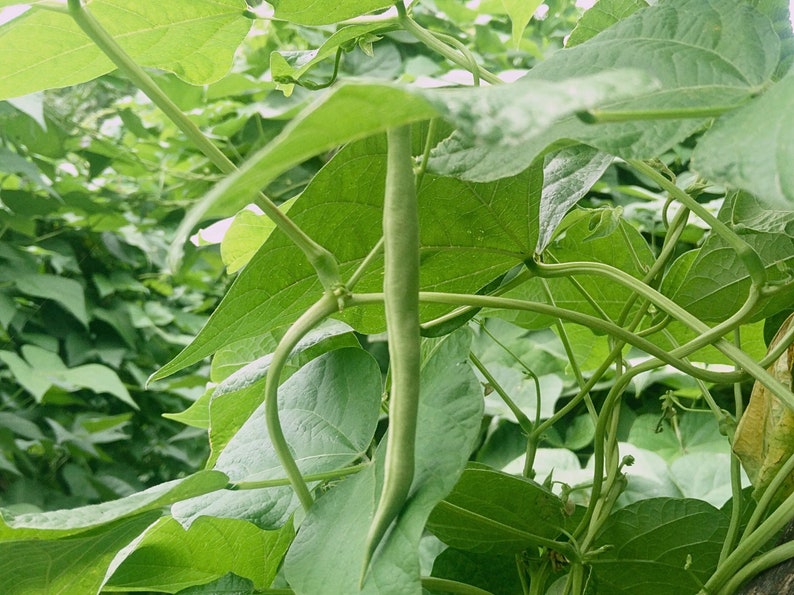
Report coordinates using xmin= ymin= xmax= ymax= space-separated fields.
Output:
xmin=431 ymin=0 xmax=780 ymax=180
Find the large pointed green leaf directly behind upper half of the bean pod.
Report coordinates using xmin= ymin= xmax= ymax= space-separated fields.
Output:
xmin=153 ymin=137 xmax=540 ymax=378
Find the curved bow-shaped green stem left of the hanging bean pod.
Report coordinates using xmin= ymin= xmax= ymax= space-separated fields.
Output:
xmin=265 ymin=292 xmax=338 ymax=510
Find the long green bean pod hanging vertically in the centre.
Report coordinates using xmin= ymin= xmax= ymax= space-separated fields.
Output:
xmin=361 ymin=126 xmax=420 ymax=583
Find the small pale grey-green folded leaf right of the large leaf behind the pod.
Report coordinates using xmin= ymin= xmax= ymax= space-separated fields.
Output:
xmin=535 ymin=145 xmax=614 ymax=254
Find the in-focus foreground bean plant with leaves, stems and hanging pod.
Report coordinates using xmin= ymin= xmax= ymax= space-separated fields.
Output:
xmin=0 ymin=0 xmax=794 ymax=595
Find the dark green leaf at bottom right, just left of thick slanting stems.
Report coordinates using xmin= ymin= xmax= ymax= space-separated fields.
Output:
xmin=592 ymin=498 xmax=728 ymax=595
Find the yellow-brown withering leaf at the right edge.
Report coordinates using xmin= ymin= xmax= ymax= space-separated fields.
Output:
xmin=733 ymin=314 xmax=794 ymax=501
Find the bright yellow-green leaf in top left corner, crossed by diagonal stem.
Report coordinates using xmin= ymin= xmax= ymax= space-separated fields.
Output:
xmin=0 ymin=0 xmax=251 ymax=99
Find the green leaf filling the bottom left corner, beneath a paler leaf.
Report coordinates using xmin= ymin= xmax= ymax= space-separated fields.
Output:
xmin=0 ymin=511 xmax=160 ymax=595
